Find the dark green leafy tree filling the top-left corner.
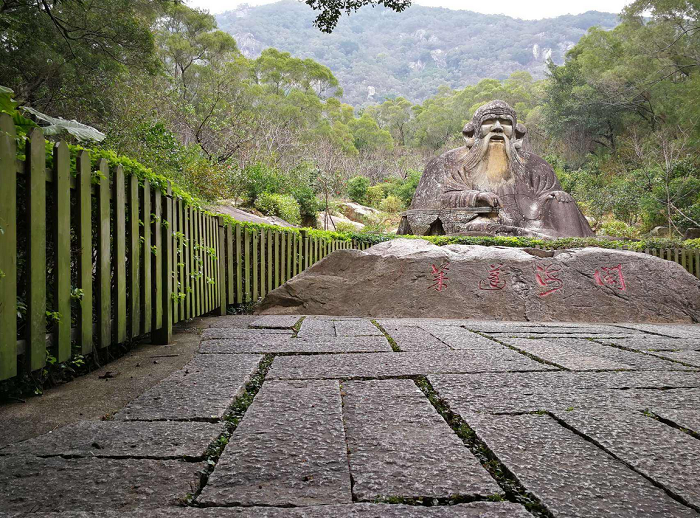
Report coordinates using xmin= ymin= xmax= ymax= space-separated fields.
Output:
xmin=0 ymin=0 xmax=161 ymax=119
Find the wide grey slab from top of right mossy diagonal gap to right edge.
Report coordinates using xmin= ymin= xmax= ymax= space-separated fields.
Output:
xmin=429 ymin=371 xmax=700 ymax=418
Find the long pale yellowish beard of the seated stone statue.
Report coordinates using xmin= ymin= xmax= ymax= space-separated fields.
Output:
xmin=460 ymin=133 xmax=523 ymax=192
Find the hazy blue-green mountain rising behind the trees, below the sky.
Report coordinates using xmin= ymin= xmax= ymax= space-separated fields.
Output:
xmin=217 ymin=0 xmax=618 ymax=107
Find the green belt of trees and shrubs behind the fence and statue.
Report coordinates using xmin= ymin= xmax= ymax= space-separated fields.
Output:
xmin=0 ymin=0 xmax=700 ymax=240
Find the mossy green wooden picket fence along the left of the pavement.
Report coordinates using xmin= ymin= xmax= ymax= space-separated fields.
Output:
xmin=0 ymin=119 xmax=369 ymax=386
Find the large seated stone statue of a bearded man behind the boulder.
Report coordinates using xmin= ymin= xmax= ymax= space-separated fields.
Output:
xmin=398 ymin=101 xmax=594 ymax=238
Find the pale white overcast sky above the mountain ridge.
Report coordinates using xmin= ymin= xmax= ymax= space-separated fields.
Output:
xmin=187 ymin=0 xmax=631 ymax=20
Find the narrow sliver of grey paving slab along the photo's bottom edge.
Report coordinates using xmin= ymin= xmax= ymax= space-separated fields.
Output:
xmin=0 ymin=502 xmax=532 ymax=518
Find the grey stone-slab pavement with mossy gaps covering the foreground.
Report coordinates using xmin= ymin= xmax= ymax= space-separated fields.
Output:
xmin=0 ymin=316 xmax=700 ymax=518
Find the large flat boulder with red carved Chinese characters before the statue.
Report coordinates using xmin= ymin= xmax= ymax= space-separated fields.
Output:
xmin=258 ymin=239 xmax=700 ymax=322
